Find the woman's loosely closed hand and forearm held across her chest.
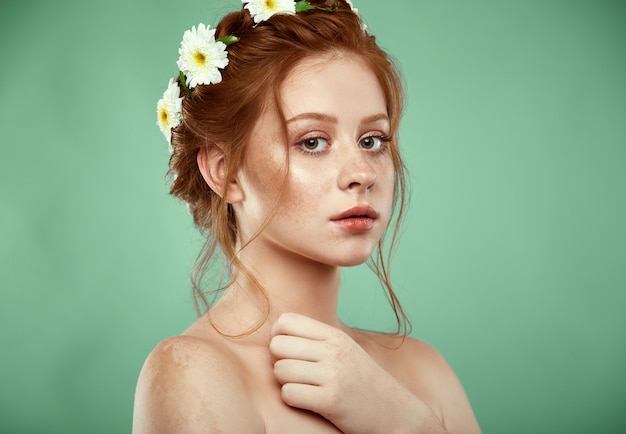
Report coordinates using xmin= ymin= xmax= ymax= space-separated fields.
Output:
xmin=270 ymin=313 xmax=445 ymax=434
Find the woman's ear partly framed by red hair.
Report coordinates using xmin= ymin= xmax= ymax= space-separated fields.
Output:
xmin=197 ymin=144 xmax=243 ymax=203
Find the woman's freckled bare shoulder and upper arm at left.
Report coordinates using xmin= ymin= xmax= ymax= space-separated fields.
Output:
xmin=133 ymin=336 xmax=261 ymax=433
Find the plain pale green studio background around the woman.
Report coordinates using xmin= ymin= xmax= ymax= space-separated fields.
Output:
xmin=0 ymin=0 xmax=626 ymax=433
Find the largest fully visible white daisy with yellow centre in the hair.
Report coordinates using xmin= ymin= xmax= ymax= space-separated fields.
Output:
xmin=176 ymin=24 xmax=228 ymax=89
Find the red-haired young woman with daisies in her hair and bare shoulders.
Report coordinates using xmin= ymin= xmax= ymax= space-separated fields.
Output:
xmin=133 ymin=0 xmax=480 ymax=434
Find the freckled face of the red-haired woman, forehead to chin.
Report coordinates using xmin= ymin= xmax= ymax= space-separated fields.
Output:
xmin=234 ymin=52 xmax=394 ymax=266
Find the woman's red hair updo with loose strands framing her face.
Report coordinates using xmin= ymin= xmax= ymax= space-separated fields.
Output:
xmin=168 ymin=0 xmax=410 ymax=333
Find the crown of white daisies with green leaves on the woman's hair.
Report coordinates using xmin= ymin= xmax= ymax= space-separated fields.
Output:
xmin=157 ymin=0 xmax=365 ymax=152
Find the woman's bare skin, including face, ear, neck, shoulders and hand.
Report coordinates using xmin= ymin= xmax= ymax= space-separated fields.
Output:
xmin=133 ymin=56 xmax=480 ymax=434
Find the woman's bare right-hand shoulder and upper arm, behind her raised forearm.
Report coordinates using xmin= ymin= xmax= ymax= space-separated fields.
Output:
xmin=354 ymin=335 xmax=481 ymax=433
